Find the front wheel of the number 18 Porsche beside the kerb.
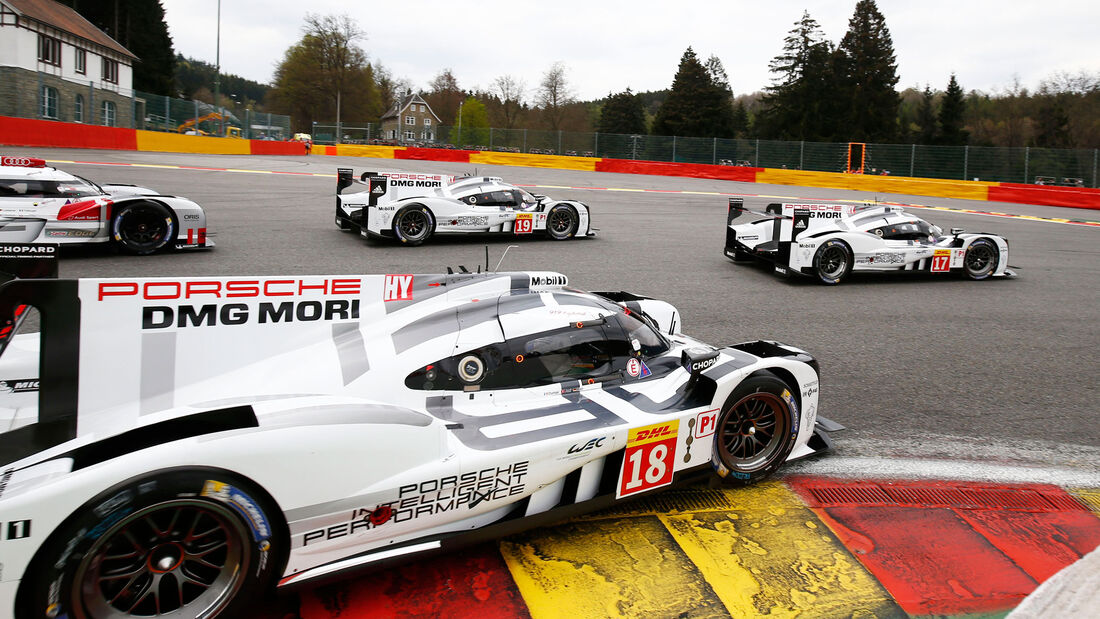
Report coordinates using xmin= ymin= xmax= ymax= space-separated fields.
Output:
xmin=713 ymin=372 xmax=799 ymax=486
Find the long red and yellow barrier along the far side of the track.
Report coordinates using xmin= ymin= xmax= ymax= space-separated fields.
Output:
xmin=0 ymin=117 xmax=1100 ymax=209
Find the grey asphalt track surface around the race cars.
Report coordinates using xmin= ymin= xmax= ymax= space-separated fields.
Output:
xmin=0 ymin=148 xmax=1100 ymax=487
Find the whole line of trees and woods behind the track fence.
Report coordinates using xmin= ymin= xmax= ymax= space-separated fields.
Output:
xmin=62 ymin=0 xmax=1100 ymax=148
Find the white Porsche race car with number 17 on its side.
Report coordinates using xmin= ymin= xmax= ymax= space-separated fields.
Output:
xmin=725 ymin=198 xmax=1015 ymax=284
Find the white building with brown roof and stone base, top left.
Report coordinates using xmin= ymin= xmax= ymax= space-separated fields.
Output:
xmin=0 ymin=0 xmax=138 ymax=128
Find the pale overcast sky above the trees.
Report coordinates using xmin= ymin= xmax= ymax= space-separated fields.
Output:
xmin=162 ymin=0 xmax=1100 ymax=100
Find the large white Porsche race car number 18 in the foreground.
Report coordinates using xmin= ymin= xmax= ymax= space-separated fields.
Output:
xmin=0 ymin=249 xmax=839 ymax=619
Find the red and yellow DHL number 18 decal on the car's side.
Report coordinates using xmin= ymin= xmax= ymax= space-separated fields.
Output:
xmin=618 ymin=419 xmax=680 ymax=497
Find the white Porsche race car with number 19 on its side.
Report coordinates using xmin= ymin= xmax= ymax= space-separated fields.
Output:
xmin=336 ymin=168 xmax=596 ymax=245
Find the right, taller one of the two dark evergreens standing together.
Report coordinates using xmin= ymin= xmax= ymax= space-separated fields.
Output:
xmin=835 ymin=0 xmax=899 ymax=142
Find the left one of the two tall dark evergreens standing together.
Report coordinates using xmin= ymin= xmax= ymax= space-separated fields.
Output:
xmin=756 ymin=11 xmax=837 ymax=140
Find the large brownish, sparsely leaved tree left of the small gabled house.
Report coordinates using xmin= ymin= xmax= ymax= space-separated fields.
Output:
xmin=268 ymin=14 xmax=383 ymax=131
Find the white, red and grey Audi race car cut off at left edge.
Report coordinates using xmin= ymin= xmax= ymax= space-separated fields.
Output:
xmin=0 ymin=156 xmax=213 ymax=254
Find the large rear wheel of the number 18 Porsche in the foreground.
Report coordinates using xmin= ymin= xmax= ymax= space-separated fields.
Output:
xmin=15 ymin=468 xmax=287 ymax=619
